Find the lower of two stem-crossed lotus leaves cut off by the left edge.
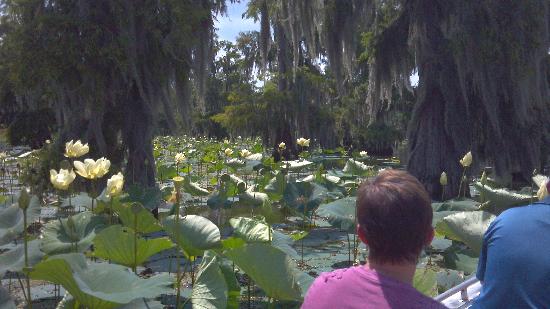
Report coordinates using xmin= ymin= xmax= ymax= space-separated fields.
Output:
xmin=0 ymin=239 xmax=44 ymax=278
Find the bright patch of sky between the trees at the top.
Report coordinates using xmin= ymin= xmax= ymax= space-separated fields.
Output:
xmin=214 ymin=0 xmax=260 ymax=42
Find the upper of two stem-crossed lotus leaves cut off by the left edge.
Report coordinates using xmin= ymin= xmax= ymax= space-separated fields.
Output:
xmin=0 ymin=196 xmax=40 ymax=246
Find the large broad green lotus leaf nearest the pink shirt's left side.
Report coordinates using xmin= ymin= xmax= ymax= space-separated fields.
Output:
xmin=225 ymin=243 xmax=302 ymax=300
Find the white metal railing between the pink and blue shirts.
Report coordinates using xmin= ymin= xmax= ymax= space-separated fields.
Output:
xmin=434 ymin=277 xmax=481 ymax=308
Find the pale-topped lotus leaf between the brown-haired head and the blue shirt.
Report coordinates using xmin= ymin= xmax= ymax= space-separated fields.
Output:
xmin=436 ymin=211 xmax=495 ymax=254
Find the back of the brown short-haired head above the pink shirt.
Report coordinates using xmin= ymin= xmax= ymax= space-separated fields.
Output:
xmin=357 ymin=169 xmax=434 ymax=264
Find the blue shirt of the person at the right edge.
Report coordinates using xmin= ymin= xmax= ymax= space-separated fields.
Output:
xmin=471 ymin=198 xmax=550 ymax=308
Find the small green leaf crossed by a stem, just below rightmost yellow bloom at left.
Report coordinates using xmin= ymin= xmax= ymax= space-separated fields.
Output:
xmin=113 ymin=203 xmax=162 ymax=234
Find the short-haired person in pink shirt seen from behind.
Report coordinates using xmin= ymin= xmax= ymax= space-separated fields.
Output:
xmin=302 ymin=170 xmax=445 ymax=309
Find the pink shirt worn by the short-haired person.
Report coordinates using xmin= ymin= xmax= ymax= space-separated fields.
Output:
xmin=302 ymin=266 xmax=446 ymax=309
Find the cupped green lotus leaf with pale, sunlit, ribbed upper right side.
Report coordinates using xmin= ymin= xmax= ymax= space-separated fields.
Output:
xmin=162 ymin=215 xmax=221 ymax=257
